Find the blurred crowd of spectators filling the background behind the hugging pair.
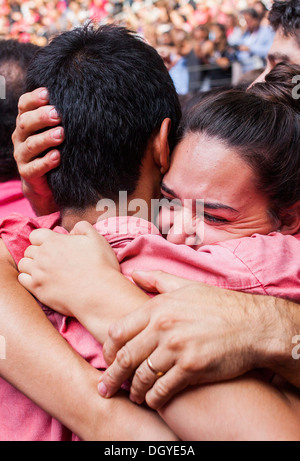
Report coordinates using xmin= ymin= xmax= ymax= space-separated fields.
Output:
xmin=0 ymin=0 xmax=273 ymax=91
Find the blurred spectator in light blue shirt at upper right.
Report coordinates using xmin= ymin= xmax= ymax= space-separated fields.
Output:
xmin=237 ymin=8 xmax=274 ymax=73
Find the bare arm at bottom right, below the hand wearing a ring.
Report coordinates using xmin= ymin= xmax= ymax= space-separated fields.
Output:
xmin=159 ymin=373 xmax=300 ymax=441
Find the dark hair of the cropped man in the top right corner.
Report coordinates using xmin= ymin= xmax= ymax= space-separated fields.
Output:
xmin=269 ymin=0 xmax=300 ymax=46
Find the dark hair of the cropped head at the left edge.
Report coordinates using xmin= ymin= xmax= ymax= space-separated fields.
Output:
xmin=0 ymin=40 xmax=38 ymax=182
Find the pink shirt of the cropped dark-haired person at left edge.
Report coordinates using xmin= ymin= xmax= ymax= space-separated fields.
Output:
xmin=0 ymin=179 xmax=35 ymax=219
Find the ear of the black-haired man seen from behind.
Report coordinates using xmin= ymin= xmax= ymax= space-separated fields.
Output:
xmin=153 ymin=118 xmax=172 ymax=174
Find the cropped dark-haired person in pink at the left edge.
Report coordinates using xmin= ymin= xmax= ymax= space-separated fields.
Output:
xmin=0 ymin=40 xmax=38 ymax=217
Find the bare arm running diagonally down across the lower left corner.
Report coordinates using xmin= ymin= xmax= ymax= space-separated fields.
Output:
xmin=0 ymin=240 xmax=176 ymax=440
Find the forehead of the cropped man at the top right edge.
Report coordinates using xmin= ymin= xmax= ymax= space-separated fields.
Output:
xmin=269 ymin=29 xmax=300 ymax=65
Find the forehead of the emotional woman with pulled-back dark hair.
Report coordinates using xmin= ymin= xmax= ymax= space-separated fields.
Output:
xmin=164 ymin=133 xmax=255 ymax=201
